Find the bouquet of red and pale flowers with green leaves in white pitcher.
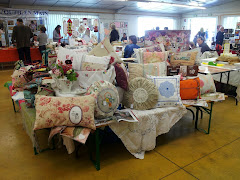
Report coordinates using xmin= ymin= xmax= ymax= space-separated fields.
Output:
xmin=52 ymin=61 xmax=79 ymax=81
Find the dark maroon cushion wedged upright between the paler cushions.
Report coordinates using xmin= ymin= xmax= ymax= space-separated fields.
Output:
xmin=114 ymin=63 xmax=128 ymax=91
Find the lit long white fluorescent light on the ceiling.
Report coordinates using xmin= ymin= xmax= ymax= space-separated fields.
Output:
xmin=137 ymin=2 xmax=206 ymax=9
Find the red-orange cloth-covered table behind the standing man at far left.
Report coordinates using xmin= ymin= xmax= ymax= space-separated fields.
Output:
xmin=0 ymin=48 xmax=42 ymax=63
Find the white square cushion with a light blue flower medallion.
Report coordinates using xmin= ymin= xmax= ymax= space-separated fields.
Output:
xmin=148 ymin=76 xmax=182 ymax=107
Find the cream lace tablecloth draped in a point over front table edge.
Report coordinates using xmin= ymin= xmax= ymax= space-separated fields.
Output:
xmin=109 ymin=107 xmax=187 ymax=159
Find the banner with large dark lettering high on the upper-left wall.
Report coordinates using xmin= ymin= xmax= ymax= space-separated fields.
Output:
xmin=0 ymin=8 xmax=48 ymax=18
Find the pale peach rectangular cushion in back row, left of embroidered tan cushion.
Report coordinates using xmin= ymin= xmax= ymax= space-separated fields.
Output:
xmin=143 ymin=52 xmax=165 ymax=64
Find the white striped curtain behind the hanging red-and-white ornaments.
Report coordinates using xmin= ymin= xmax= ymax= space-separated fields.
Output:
xmin=47 ymin=13 xmax=98 ymax=39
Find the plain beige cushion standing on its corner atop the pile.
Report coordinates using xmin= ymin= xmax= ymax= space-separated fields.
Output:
xmin=89 ymin=37 xmax=123 ymax=63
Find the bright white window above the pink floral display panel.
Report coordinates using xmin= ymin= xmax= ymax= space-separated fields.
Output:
xmin=138 ymin=17 xmax=176 ymax=37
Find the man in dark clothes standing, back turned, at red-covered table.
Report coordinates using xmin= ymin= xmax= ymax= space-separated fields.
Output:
xmin=12 ymin=19 xmax=33 ymax=64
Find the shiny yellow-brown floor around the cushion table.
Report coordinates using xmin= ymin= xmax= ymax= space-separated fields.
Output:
xmin=0 ymin=71 xmax=240 ymax=180
